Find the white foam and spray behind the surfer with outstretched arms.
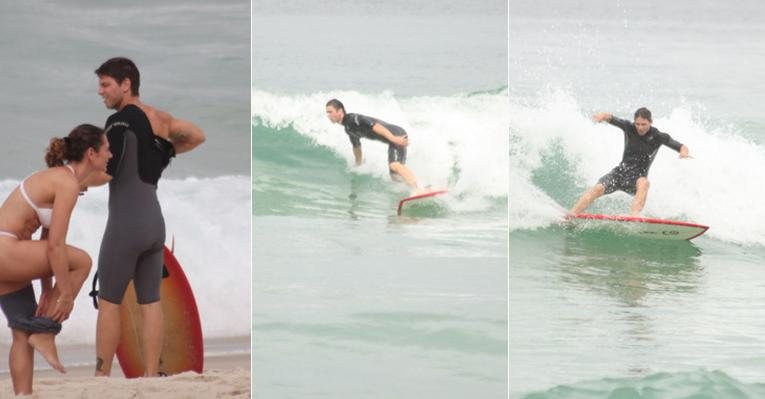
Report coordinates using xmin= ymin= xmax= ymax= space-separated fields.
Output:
xmin=510 ymin=90 xmax=765 ymax=245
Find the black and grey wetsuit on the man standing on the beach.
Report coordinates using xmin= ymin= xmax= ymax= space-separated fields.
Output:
xmin=98 ymin=105 xmax=175 ymax=304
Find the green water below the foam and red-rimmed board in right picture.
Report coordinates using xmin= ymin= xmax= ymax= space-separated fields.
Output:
xmin=510 ymin=227 xmax=765 ymax=398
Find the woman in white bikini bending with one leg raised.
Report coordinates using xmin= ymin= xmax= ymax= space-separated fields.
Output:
xmin=0 ymin=125 xmax=112 ymax=397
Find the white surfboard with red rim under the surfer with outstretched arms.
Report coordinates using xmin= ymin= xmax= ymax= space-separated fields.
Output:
xmin=566 ymin=213 xmax=709 ymax=240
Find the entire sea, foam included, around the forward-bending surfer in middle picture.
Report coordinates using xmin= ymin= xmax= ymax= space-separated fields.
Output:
xmin=251 ymin=0 xmax=508 ymax=398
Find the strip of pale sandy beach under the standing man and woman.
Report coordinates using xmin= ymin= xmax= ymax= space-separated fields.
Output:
xmin=0 ymin=337 xmax=251 ymax=399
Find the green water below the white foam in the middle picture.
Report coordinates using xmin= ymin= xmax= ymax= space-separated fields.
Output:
xmin=252 ymin=99 xmax=507 ymax=398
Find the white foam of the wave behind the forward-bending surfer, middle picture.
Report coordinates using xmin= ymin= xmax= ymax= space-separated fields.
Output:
xmin=252 ymin=89 xmax=508 ymax=211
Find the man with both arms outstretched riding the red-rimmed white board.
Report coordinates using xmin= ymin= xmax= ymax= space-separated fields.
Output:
xmin=571 ymin=108 xmax=690 ymax=216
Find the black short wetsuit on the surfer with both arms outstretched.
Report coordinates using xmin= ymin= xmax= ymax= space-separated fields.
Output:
xmin=598 ymin=116 xmax=683 ymax=195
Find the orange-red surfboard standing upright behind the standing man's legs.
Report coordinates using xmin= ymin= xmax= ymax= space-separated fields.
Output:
xmin=117 ymin=247 xmax=204 ymax=378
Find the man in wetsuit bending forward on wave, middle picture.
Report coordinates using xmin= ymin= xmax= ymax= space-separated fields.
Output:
xmin=326 ymin=99 xmax=424 ymax=194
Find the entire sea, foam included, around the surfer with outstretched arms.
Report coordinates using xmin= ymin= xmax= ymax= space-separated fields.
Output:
xmin=509 ymin=1 xmax=765 ymax=398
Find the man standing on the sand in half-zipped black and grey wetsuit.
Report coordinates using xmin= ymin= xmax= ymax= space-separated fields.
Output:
xmin=95 ymin=58 xmax=205 ymax=376
